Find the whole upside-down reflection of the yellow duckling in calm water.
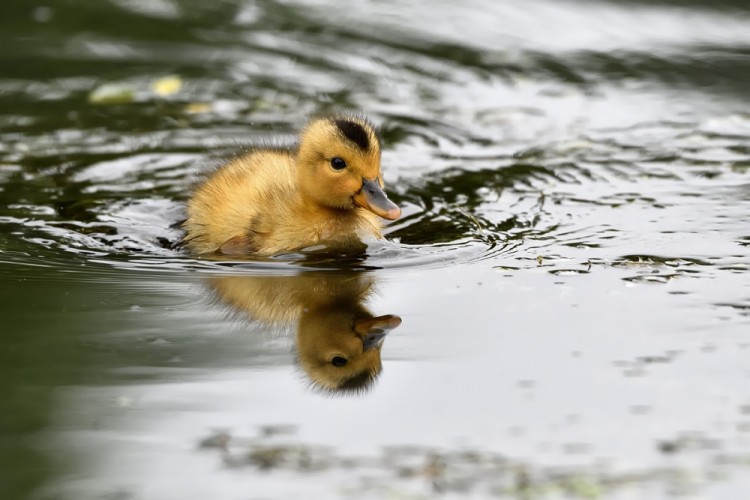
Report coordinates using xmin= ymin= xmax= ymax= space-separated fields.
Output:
xmin=211 ymin=272 xmax=401 ymax=391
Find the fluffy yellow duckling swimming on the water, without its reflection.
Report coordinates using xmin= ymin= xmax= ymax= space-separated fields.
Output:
xmin=183 ymin=116 xmax=401 ymax=255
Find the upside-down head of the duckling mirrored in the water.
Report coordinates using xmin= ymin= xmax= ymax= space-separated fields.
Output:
xmin=297 ymin=304 xmax=401 ymax=392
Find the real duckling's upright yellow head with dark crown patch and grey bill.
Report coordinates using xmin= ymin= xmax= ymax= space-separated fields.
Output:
xmin=297 ymin=116 xmax=401 ymax=220
